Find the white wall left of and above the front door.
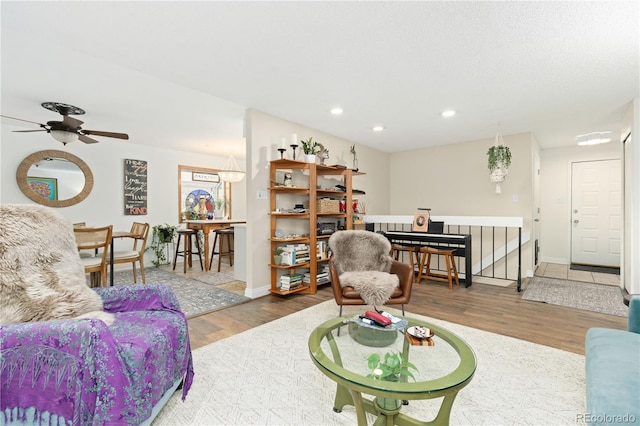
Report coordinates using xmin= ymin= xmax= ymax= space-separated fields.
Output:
xmin=540 ymin=142 xmax=621 ymax=265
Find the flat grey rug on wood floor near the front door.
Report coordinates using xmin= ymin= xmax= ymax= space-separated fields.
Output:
xmin=522 ymin=277 xmax=629 ymax=317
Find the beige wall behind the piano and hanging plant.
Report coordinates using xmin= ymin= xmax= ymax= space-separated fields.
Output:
xmin=390 ymin=133 xmax=537 ymax=275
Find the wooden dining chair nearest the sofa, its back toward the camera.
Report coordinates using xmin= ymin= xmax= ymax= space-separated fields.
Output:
xmin=73 ymin=225 xmax=113 ymax=287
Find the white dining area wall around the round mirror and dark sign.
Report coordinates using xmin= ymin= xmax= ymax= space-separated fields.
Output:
xmin=0 ymin=125 xmax=246 ymax=266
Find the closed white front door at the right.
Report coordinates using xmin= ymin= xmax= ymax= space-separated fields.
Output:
xmin=571 ymin=160 xmax=622 ymax=267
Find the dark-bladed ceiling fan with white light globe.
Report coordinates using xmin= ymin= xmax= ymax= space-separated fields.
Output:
xmin=1 ymin=102 xmax=129 ymax=145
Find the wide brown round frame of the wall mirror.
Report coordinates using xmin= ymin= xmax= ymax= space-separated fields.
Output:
xmin=16 ymin=149 xmax=93 ymax=207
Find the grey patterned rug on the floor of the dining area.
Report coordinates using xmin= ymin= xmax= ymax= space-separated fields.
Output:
xmin=113 ymin=267 xmax=251 ymax=318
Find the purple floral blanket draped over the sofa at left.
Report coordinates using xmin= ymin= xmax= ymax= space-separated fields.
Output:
xmin=0 ymin=284 xmax=193 ymax=425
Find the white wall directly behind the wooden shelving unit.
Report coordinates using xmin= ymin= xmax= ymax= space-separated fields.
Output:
xmin=245 ymin=110 xmax=390 ymax=297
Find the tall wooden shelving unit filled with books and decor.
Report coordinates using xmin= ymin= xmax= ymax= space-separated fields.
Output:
xmin=269 ymin=159 xmax=364 ymax=295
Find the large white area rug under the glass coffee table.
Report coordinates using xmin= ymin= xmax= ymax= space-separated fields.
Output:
xmin=153 ymin=301 xmax=586 ymax=426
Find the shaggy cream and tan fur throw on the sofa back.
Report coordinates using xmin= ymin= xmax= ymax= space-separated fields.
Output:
xmin=0 ymin=204 xmax=114 ymax=324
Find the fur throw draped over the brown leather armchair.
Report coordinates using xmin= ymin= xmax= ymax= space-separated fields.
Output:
xmin=329 ymin=230 xmax=400 ymax=306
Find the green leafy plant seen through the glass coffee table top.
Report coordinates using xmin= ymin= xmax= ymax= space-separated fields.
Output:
xmin=367 ymin=352 xmax=418 ymax=410
